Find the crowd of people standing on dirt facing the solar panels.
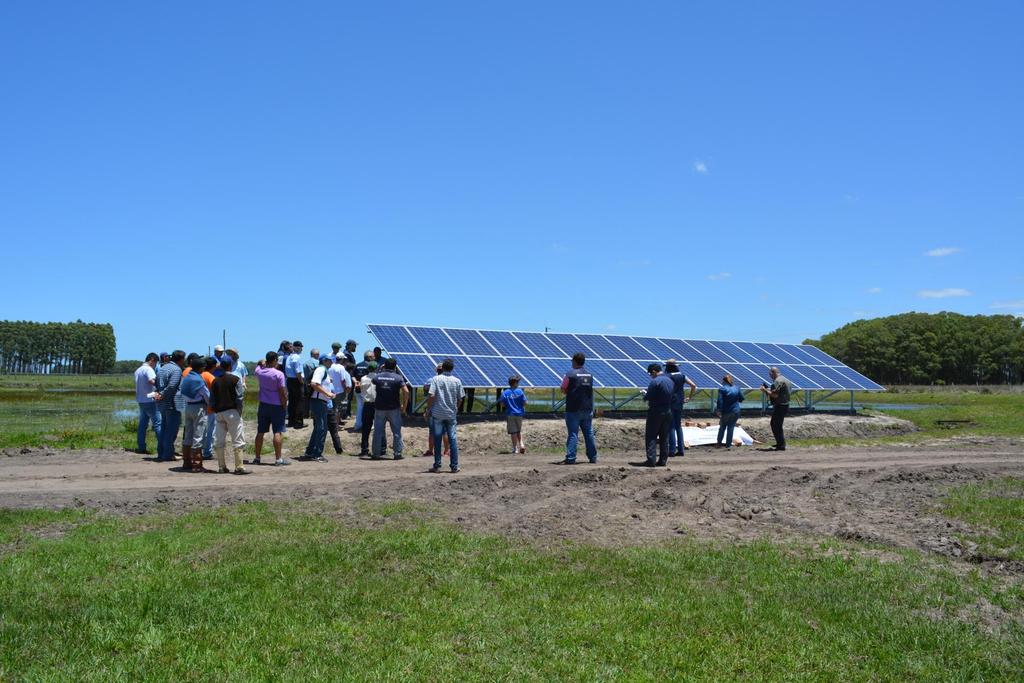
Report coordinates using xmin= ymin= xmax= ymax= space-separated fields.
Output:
xmin=135 ymin=339 xmax=792 ymax=474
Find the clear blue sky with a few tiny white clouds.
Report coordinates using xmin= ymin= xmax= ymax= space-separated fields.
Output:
xmin=0 ymin=1 xmax=1024 ymax=358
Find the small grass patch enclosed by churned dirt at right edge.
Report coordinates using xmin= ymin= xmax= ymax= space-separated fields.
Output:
xmin=942 ymin=477 xmax=1024 ymax=561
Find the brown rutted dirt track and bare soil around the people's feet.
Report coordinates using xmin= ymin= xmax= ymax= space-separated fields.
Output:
xmin=0 ymin=415 xmax=1024 ymax=575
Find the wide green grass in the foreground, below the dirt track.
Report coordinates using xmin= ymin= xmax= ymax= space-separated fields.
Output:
xmin=0 ymin=505 xmax=1024 ymax=681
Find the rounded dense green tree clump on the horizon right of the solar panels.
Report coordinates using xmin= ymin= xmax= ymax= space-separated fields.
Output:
xmin=805 ymin=312 xmax=1024 ymax=384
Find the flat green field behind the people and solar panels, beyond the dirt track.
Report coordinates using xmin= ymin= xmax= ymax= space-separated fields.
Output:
xmin=0 ymin=375 xmax=1024 ymax=451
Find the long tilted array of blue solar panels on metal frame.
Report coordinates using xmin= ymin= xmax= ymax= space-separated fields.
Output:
xmin=369 ymin=325 xmax=884 ymax=391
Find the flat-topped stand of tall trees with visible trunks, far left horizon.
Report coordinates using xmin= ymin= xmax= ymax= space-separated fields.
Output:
xmin=0 ymin=321 xmax=117 ymax=375
